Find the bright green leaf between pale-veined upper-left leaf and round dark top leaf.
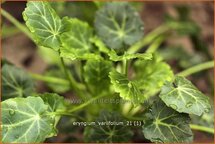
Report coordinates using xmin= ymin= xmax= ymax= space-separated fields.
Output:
xmin=60 ymin=18 xmax=100 ymax=60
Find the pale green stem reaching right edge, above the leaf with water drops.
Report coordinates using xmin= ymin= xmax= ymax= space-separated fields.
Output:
xmin=177 ymin=60 xmax=214 ymax=77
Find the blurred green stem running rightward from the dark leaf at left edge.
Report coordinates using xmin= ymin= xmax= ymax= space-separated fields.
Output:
xmin=29 ymin=73 xmax=69 ymax=86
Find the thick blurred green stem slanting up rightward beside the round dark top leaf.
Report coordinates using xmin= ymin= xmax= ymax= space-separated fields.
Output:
xmin=128 ymin=25 xmax=169 ymax=53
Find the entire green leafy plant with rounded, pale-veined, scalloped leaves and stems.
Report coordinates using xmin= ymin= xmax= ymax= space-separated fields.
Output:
xmin=1 ymin=1 xmax=214 ymax=143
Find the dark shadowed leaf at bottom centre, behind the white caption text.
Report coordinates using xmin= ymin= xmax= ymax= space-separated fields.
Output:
xmin=84 ymin=111 xmax=133 ymax=143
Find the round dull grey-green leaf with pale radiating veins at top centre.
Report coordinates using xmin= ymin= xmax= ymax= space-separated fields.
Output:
xmin=95 ymin=2 xmax=143 ymax=49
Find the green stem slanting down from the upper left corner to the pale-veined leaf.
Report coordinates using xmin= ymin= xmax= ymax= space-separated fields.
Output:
xmin=1 ymin=9 xmax=33 ymax=41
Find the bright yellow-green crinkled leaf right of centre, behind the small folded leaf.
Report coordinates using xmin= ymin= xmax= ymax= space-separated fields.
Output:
xmin=134 ymin=55 xmax=173 ymax=98
